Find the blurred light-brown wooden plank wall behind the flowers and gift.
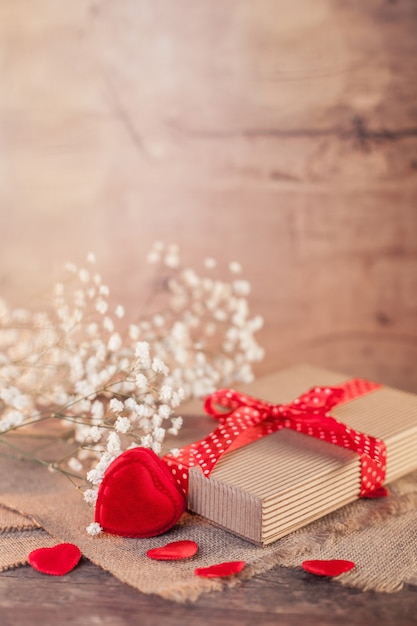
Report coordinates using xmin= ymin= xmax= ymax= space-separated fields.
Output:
xmin=0 ymin=0 xmax=417 ymax=391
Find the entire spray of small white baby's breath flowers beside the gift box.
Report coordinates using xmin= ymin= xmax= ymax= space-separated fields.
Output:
xmin=0 ymin=243 xmax=263 ymax=520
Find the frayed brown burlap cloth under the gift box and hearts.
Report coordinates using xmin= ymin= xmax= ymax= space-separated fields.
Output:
xmin=0 ymin=442 xmax=417 ymax=602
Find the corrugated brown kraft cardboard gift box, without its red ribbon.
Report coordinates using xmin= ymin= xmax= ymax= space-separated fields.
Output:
xmin=183 ymin=366 xmax=417 ymax=545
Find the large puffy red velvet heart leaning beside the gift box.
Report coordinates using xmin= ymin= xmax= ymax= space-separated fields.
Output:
xmin=95 ymin=447 xmax=185 ymax=537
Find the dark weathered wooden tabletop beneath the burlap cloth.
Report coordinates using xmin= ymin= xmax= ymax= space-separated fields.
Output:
xmin=0 ymin=417 xmax=417 ymax=626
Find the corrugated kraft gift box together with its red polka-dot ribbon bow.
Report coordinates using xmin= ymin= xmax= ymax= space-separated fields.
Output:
xmin=165 ymin=366 xmax=417 ymax=545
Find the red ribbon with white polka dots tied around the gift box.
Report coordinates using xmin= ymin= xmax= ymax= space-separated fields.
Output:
xmin=164 ymin=379 xmax=386 ymax=497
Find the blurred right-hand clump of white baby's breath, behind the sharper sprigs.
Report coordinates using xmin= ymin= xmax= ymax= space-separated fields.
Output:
xmin=130 ymin=242 xmax=264 ymax=398
